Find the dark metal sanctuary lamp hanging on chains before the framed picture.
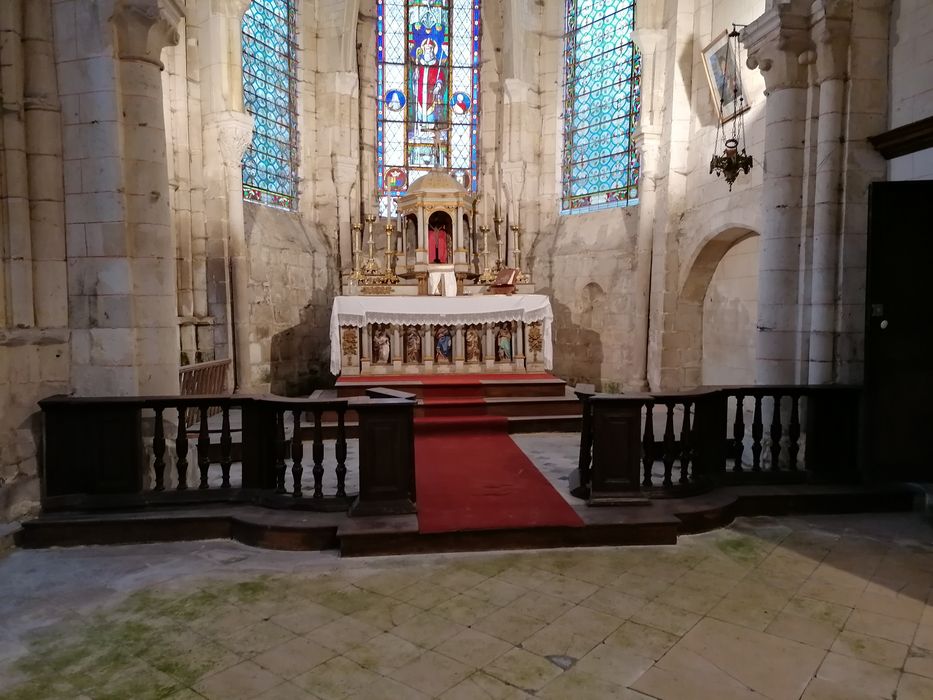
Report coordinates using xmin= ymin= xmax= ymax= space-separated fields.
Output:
xmin=709 ymin=24 xmax=752 ymax=192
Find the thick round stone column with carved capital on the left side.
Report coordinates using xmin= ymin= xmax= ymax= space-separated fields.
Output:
xmin=111 ymin=0 xmax=183 ymax=394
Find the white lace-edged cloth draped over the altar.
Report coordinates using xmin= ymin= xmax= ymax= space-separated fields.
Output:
xmin=330 ymin=294 xmax=554 ymax=374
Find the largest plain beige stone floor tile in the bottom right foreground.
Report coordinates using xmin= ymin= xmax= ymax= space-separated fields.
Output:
xmin=676 ymin=618 xmax=824 ymax=700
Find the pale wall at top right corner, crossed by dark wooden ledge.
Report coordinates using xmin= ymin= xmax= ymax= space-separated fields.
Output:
xmin=888 ymin=0 xmax=933 ymax=180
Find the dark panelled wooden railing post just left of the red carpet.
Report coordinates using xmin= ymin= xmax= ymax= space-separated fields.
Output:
xmin=350 ymin=390 xmax=417 ymax=516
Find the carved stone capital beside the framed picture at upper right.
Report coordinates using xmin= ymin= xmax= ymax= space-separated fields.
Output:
xmin=740 ymin=0 xmax=813 ymax=95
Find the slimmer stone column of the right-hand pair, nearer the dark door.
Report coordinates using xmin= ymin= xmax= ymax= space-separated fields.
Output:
xmin=807 ymin=0 xmax=852 ymax=384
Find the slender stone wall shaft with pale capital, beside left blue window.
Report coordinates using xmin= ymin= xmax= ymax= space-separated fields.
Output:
xmin=205 ymin=111 xmax=253 ymax=392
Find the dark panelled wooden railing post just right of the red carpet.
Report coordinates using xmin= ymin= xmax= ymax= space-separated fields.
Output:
xmin=588 ymin=394 xmax=651 ymax=505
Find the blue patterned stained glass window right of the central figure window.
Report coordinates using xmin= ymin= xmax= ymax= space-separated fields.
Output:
xmin=561 ymin=0 xmax=640 ymax=212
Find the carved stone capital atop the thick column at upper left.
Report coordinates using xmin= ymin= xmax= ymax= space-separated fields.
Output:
xmin=110 ymin=0 xmax=185 ymax=69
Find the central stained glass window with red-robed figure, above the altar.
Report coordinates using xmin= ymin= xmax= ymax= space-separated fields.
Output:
xmin=376 ymin=0 xmax=480 ymax=215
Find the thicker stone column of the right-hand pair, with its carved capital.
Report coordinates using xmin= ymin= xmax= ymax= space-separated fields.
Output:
xmin=741 ymin=0 xmax=810 ymax=384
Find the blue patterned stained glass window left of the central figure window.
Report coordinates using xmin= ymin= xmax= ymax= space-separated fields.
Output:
xmin=242 ymin=0 xmax=298 ymax=209
